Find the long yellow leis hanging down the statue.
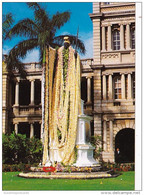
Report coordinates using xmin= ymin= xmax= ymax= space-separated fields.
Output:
xmin=42 ymin=46 xmax=81 ymax=165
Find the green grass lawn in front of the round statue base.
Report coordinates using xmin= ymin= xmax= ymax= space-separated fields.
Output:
xmin=2 ymin=171 xmax=134 ymax=191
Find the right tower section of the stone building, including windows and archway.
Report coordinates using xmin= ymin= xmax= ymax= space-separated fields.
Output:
xmin=90 ymin=2 xmax=135 ymax=162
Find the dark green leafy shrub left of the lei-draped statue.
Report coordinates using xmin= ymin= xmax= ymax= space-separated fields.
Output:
xmin=2 ymin=132 xmax=42 ymax=164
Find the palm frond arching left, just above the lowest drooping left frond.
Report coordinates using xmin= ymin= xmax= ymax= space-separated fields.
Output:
xmin=6 ymin=18 xmax=38 ymax=38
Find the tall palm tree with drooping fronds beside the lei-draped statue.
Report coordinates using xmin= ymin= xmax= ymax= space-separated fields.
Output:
xmin=6 ymin=3 xmax=85 ymax=72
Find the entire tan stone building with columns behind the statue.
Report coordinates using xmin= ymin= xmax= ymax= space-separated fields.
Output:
xmin=2 ymin=2 xmax=135 ymax=162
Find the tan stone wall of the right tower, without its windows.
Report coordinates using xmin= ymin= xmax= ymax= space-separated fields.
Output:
xmin=91 ymin=2 xmax=135 ymax=162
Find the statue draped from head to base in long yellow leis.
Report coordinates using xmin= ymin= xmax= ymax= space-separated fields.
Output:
xmin=42 ymin=37 xmax=81 ymax=166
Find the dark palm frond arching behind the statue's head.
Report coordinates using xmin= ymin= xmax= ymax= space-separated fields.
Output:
xmin=53 ymin=35 xmax=86 ymax=54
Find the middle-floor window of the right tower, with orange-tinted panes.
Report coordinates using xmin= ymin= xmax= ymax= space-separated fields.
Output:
xmin=114 ymin=76 xmax=121 ymax=99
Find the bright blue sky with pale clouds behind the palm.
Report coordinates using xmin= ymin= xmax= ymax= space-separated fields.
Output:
xmin=2 ymin=2 xmax=93 ymax=63
